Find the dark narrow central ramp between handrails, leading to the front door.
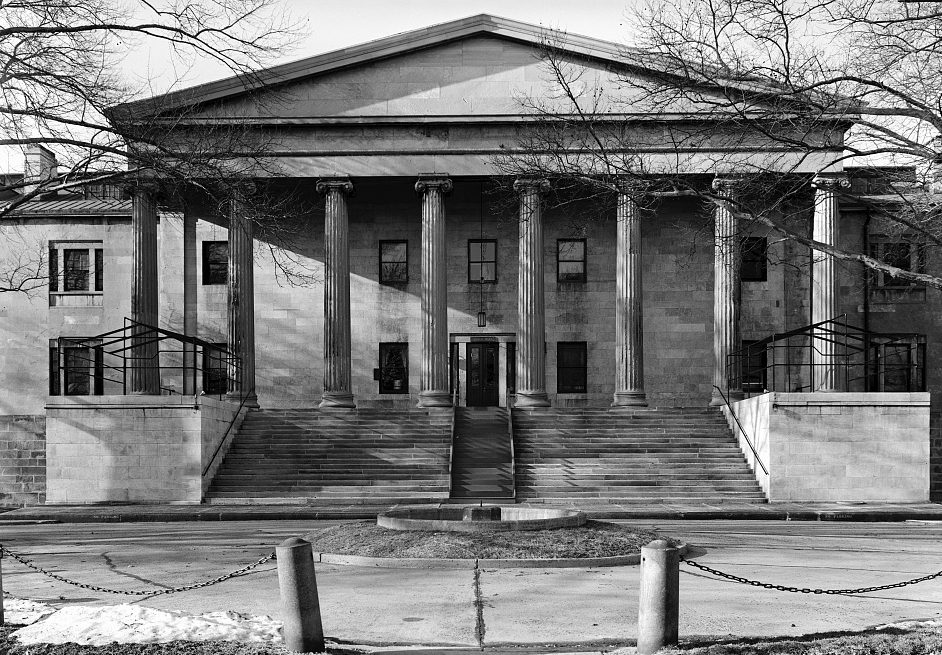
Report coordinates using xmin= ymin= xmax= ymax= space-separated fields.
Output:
xmin=451 ymin=407 xmax=514 ymax=501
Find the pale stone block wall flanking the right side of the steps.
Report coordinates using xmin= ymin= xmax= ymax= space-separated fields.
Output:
xmin=731 ymin=393 xmax=929 ymax=502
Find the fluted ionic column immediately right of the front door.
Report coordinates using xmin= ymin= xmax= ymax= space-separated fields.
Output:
xmin=514 ymin=179 xmax=550 ymax=407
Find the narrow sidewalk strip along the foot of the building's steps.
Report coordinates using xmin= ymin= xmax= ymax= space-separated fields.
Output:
xmin=0 ymin=499 xmax=942 ymax=523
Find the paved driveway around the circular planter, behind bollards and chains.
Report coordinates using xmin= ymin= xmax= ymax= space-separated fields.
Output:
xmin=3 ymin=520 xmax=942 ymax=650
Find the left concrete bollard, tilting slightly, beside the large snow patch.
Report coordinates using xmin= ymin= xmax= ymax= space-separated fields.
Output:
xmin=275 ymin=537 xmax=324 ymax=653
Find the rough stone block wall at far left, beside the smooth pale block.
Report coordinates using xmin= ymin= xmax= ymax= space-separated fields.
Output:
xmin=0 ymin=414 xmax=46 ymax=507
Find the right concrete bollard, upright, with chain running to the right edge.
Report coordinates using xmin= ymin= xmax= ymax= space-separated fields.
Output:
xmin=638 ymin=539 xmax=680 ymax=655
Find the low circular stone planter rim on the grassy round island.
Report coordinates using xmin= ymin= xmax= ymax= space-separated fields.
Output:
xmin=376 ymin=506 xmax=586 ymax=532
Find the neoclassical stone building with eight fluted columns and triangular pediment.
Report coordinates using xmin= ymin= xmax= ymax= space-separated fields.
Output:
xmin=0 ymin=16 xmax=942 ymax=503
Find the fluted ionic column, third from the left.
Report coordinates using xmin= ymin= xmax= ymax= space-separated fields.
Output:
xmin=316 ymin=178 xmax=356 ymax=408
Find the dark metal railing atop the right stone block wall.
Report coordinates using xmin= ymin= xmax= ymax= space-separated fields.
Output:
xmin=726 ymin=315 xmax=926 ymax=397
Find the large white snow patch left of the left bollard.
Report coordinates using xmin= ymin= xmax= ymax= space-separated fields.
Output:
xmin=12 ymin=605 xmax=282 ymax=646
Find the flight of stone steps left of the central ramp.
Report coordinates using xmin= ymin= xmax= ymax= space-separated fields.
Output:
xmin=206 ymin=409 xmax=452 ymax=504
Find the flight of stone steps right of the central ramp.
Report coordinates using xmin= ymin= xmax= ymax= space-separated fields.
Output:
xmin=513 ymin=408 xmax=766 ymax=503
